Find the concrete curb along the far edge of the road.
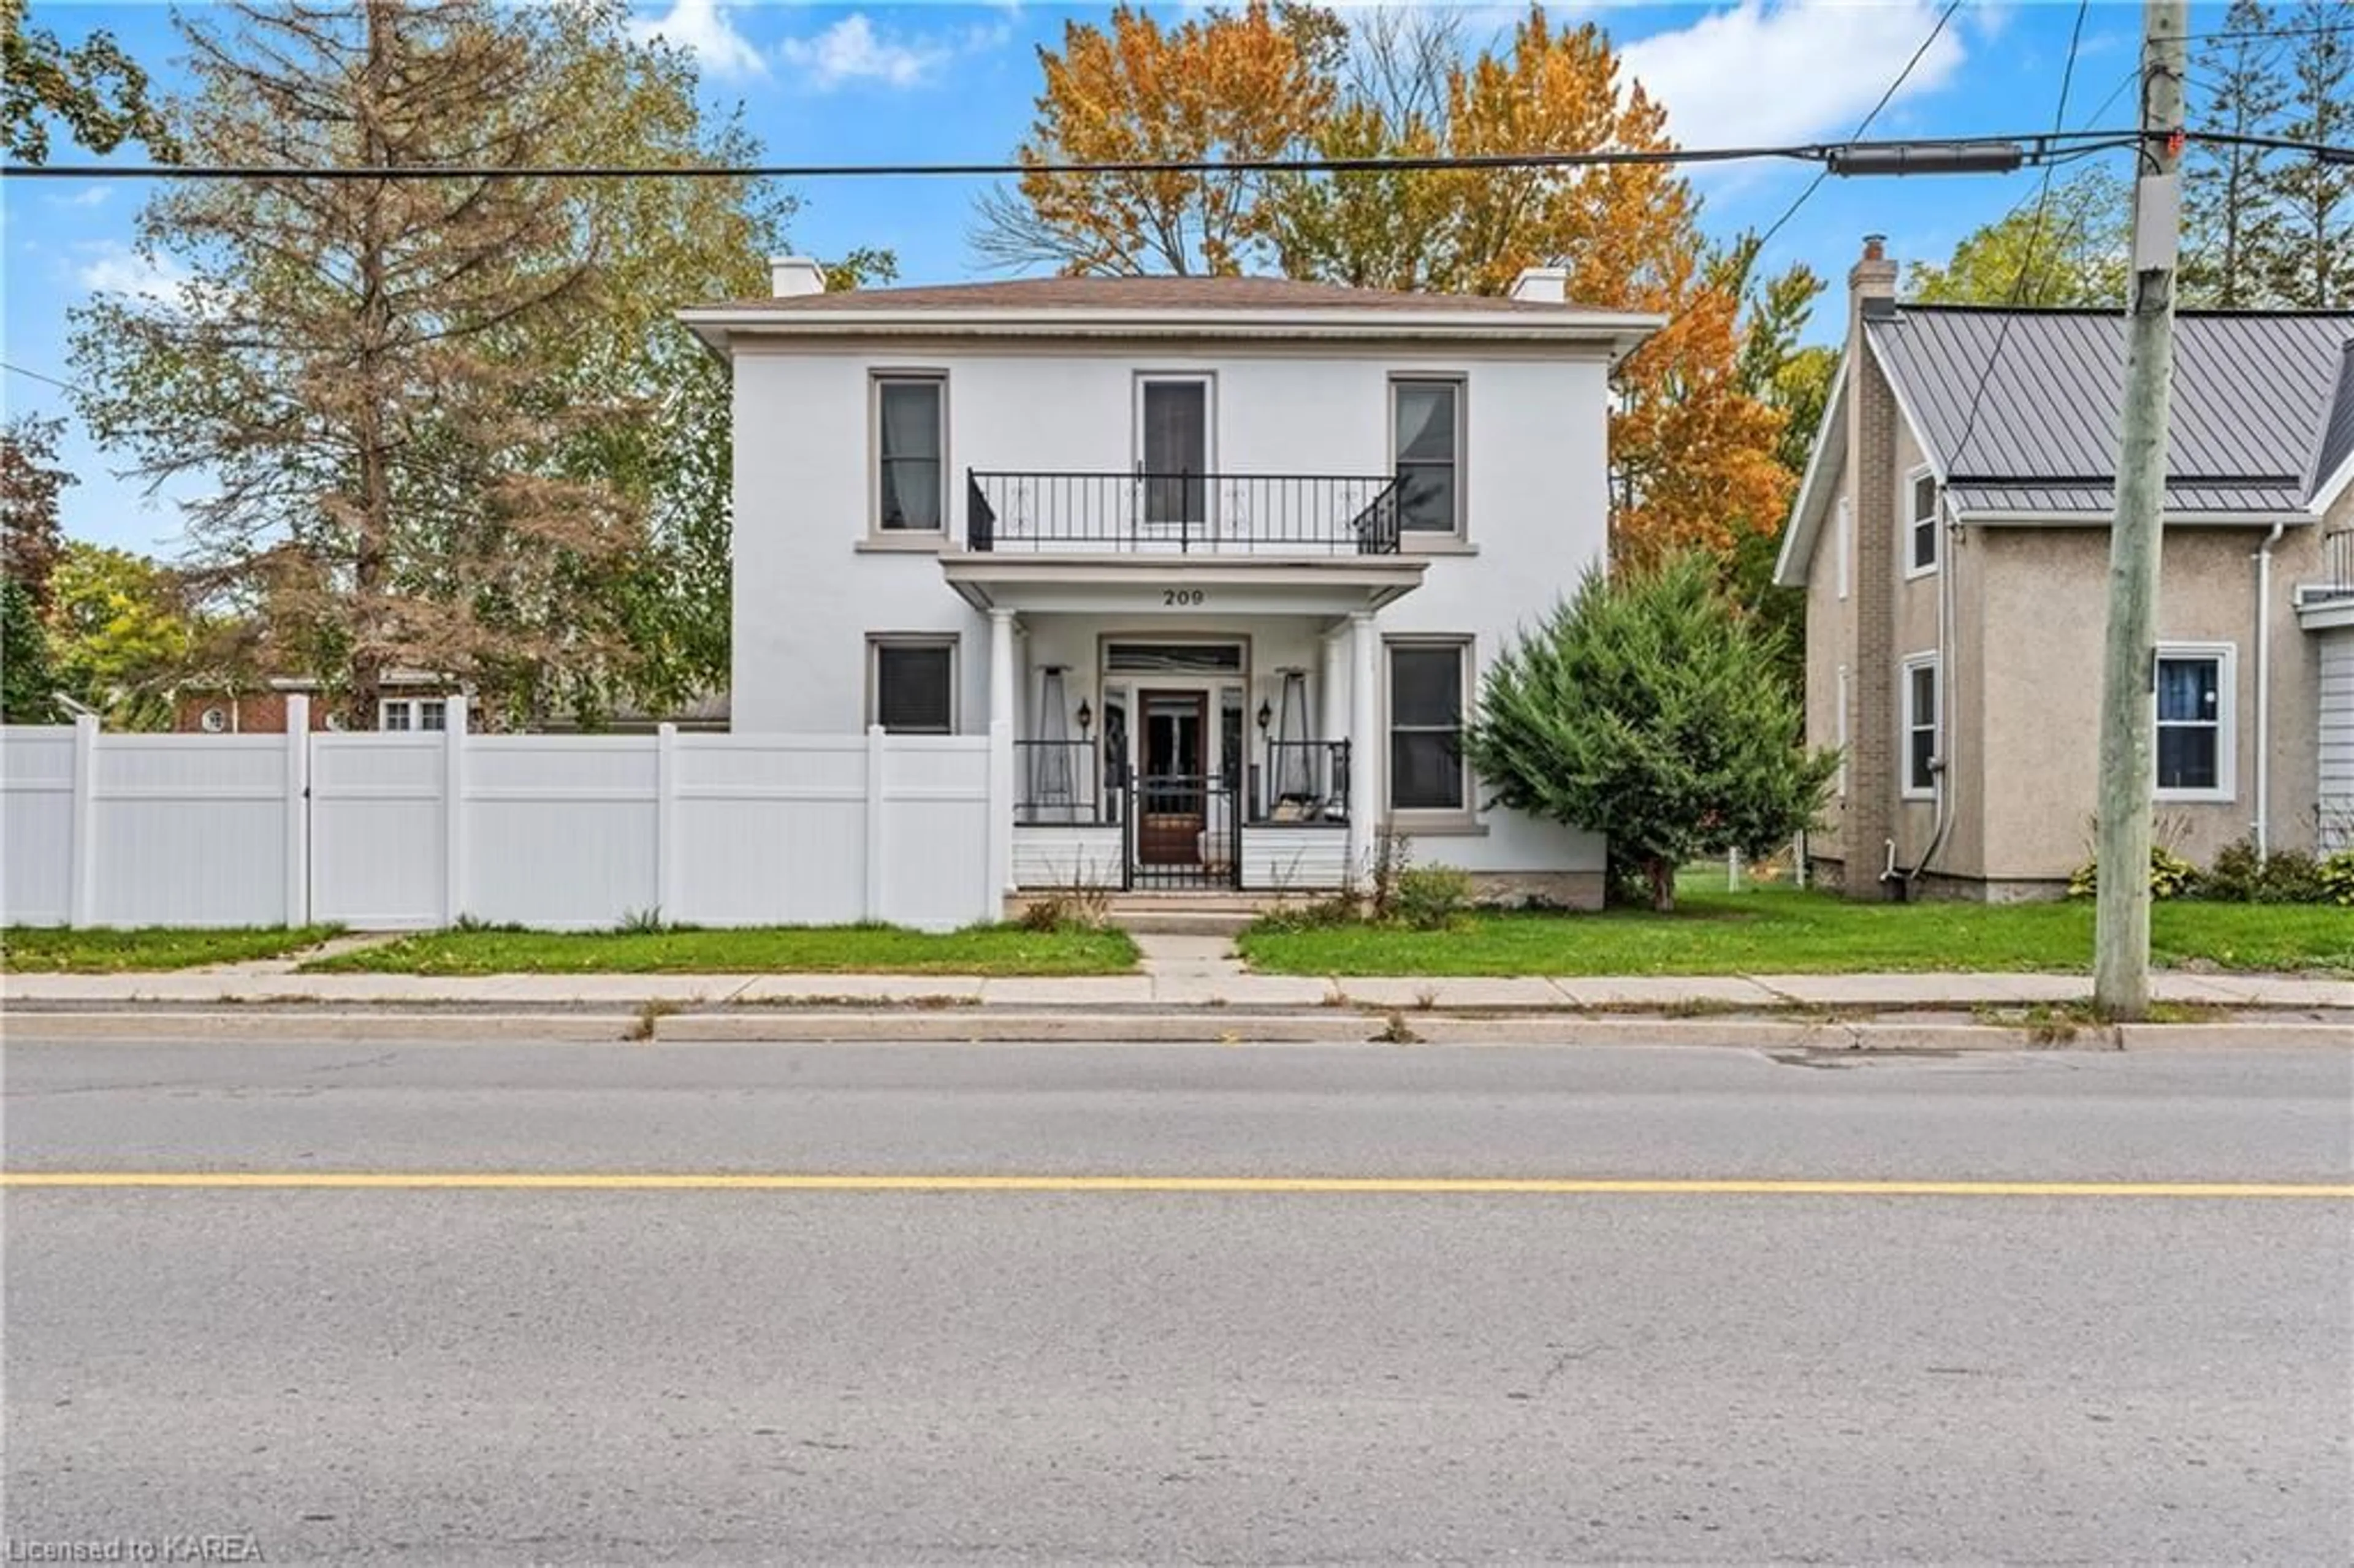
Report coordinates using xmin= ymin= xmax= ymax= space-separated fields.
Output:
xmin=7 ymin=1008 xmax=2354 ymax=1055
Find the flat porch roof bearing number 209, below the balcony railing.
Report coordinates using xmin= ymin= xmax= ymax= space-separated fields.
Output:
xmin=939 ymin=551 xmax=1429 ymax=617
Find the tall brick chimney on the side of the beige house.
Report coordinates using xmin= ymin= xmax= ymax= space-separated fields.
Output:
xmin=1841 ymin=233 xmax=1900 ymax=899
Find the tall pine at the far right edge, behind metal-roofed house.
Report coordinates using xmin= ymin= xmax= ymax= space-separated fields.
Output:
xmin=2274 ymin=0 xmax=2354 ymax=311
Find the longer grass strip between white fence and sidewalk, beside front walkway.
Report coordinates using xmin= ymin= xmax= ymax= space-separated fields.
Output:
xmin=308 ymin=925 xmax=1137 ymax=975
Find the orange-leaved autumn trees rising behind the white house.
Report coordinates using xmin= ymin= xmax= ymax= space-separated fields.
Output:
xmin=981 ymin=5 xmax=1819 ymax=560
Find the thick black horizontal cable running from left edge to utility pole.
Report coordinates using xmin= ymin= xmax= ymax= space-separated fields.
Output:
xmin=0 ymin=132 xmax=2133 ymax=181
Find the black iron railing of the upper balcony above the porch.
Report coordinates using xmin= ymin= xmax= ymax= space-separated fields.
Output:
xmin=965 ymin=468 xmax=1398 ymax=555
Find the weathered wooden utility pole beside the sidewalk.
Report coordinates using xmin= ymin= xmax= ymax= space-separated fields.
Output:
xmin=2093 ymin=0 xmax=2189 ymax=1019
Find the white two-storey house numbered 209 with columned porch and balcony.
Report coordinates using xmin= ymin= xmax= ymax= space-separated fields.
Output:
xmin=680 ymin=259 xmax=1659 ymax=907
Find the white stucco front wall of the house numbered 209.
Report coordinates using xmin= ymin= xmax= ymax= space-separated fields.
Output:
xmin=732 ymin=341 xmax=1608 ymax=871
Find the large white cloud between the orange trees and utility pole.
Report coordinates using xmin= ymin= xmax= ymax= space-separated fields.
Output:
xmin=1620 ymin=0 xmax=1965 ymax=146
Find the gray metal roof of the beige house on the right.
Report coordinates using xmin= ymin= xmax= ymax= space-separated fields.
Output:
xmin=1864 ymin=306 xmax=2354 ymax=513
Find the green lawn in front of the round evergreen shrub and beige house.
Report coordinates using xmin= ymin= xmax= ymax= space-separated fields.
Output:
xmin=1241 ymin=878 xmax=2354 ymax=975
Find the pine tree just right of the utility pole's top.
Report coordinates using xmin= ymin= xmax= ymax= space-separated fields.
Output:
xmin=2182 ymin=0 xmax=2288 ymax=308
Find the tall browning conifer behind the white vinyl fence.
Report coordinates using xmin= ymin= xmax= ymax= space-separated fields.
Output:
xmin=75 ymin=0 xmax=642 ymax=725
